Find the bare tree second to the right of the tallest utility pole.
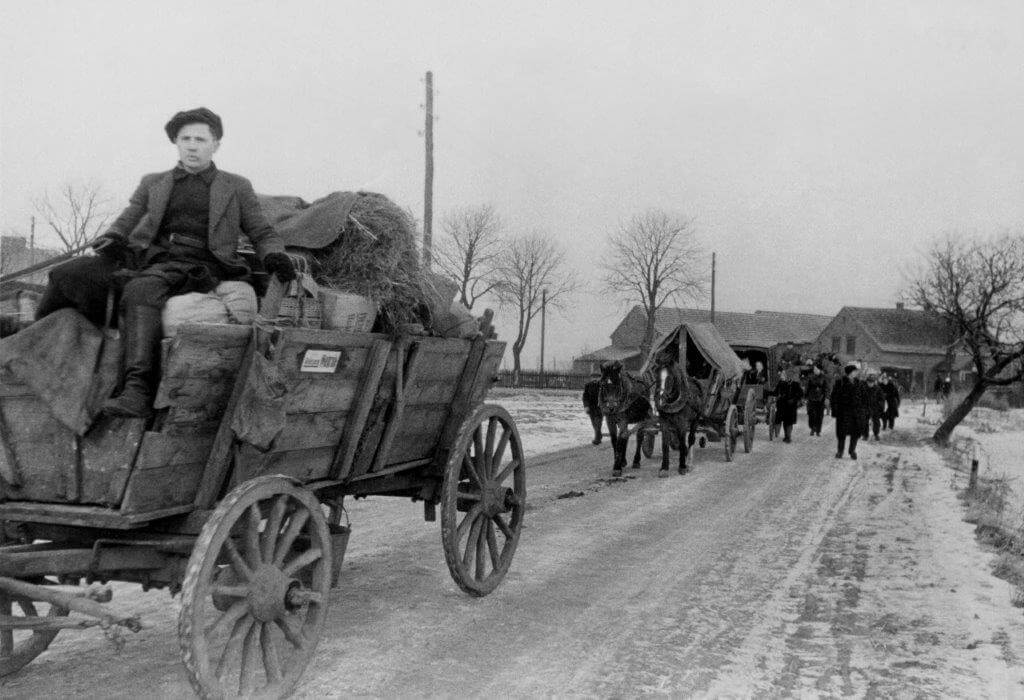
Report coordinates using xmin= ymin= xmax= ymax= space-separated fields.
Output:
xmin=495 ymin=232 xmax=580 ymax=385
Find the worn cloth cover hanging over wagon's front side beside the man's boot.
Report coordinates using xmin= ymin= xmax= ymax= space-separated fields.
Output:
xmin=0 ymin=309 xmax=121 ymax=435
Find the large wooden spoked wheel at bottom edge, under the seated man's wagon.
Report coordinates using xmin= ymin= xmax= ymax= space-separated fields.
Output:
xmin=178 ymin=477 xmax=331 ymax=698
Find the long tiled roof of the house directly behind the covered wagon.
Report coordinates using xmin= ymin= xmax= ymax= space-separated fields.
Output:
xmin=654 ymin=308 xmax=833 ymax=348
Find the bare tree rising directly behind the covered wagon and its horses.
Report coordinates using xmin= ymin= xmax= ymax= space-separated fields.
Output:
xmin=601 ymin=209 xmax=705 ymax=355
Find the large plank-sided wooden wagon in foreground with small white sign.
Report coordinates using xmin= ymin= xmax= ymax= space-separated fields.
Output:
xmin=0 ymin=312 xmax=525 ymax=697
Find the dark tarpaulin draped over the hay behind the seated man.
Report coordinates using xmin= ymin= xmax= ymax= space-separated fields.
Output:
xmin=258 ymin=192 xmax=359 ymax=250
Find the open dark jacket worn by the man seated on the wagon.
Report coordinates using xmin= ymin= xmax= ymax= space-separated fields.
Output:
xmin=108 ymin=170 xmax=285 ymax=269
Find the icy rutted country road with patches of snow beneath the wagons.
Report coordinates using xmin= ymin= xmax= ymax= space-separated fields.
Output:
xmin=0 ymin=392 xmax=1024 ymax=698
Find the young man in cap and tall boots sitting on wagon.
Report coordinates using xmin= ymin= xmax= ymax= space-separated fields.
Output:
xmin=37 ymin=107 xmax=295 ymax=417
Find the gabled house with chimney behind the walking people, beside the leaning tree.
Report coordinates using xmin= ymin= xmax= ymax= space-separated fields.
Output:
xmin=811 ymin=304 xmax=965 ymax=393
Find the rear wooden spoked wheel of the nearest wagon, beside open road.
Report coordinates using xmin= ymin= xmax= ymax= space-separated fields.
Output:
xmin=441 ymin=405 xmax=526 ymax=596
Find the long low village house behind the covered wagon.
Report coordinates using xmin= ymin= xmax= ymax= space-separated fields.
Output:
xmin=572 ymin=306 xmax=833 ymax=374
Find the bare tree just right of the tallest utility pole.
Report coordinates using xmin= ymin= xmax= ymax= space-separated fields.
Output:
xmin=433 ymin=205 xmax=504 ymax=309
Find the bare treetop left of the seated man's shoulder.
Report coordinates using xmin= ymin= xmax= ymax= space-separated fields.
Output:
xmin=32 ymin=182 xmax=111 ymax=253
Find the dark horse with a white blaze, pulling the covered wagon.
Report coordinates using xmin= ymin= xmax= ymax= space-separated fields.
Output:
xmin=649 ymin=350 xmax=701 ymax=477
